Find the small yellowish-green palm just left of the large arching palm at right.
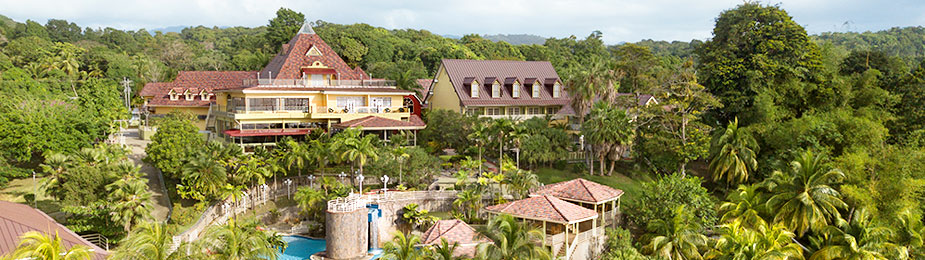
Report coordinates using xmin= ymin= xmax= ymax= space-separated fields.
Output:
xmin=719 ymin=185 xmax=767 ymax=228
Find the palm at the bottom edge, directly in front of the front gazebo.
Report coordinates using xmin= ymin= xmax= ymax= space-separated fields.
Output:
xmin=476 ymin=214 xmax=551 ymax=259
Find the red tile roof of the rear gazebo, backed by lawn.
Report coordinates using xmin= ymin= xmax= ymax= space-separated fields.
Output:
xmin=530 ymin=178 xmax=623 ymax=203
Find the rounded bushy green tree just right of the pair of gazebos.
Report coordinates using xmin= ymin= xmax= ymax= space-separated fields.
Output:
xmin=626 ymin=174 xmax=717 ymax=232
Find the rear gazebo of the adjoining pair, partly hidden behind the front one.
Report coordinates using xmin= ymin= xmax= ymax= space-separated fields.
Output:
xmin=530 ymin=178 xmax=623 ymax=226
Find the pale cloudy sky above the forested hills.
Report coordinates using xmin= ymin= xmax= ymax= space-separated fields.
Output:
xmin=0 ymin=0 xmax=925 ymax=44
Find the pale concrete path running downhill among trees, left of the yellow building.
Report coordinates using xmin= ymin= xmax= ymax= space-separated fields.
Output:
xmin=116 ymin=129 xmax=170 ymax=221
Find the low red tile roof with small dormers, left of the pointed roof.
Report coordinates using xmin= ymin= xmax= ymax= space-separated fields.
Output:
xmin=139 ymin=71 xmax=257 ymax=107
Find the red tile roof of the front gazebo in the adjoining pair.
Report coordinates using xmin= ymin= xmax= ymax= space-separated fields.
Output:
xmin=485 ymin=196 xmax=598 ymax=223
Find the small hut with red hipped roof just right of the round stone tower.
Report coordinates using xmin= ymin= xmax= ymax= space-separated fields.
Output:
xmin=421 ymin=219 xmax=491 ymax=257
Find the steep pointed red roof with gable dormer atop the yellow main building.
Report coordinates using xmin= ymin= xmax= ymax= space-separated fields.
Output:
xmin=260 ymin=33 xmax=370 ymax=80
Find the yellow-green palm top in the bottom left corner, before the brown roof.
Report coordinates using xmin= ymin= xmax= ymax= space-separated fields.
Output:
xmin=10 ymin=231 xmax=90 ymax=260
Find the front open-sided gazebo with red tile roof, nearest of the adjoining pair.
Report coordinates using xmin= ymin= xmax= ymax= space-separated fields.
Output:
xmin=485 ymin=195 xmax=599 ymax=259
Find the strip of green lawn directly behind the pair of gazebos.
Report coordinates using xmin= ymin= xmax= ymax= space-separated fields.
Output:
xmin=533 ymin=165 xmax=648 ymax=203
